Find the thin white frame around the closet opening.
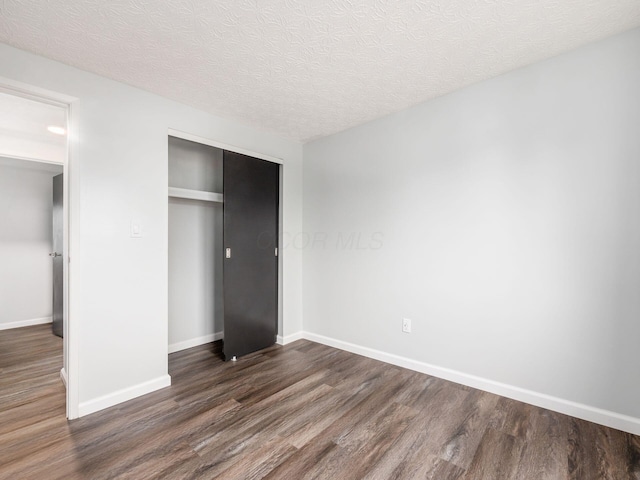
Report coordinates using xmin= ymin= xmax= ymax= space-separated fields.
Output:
xmin=166 ymin=128 xmax=286 ymax=352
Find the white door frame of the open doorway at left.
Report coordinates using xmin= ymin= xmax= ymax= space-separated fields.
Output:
xmin=0 ymin=77 xmax=80 ymax=419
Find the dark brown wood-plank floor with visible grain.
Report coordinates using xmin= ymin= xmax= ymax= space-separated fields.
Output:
xmin=0 ymin=325 xmax=640 ymax=480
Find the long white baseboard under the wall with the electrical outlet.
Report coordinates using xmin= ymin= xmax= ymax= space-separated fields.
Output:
xmin=302 ymin=332 xmax=640 ymax=435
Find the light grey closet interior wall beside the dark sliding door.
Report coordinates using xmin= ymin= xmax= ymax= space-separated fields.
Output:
xmin=168 ymin=137 xmax=224 ymax=353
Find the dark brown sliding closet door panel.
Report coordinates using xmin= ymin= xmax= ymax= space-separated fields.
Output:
xmin=223 ymin=151 xmax=280 ymax=360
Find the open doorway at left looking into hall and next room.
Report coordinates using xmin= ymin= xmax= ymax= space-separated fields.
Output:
xmin=0 ymin=84 xmax=69 ymax=416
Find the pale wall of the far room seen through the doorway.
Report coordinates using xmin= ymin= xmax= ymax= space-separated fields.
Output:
xmin=0 ymin=157 xmax=62 ymax=329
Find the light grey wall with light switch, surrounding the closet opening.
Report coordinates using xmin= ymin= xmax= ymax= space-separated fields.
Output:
xmin=0 ymin=45 xmax=302 ymax=417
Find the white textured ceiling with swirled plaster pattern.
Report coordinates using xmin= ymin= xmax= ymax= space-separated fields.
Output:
xmin=0 ymin=0 xmax=640 ymax=141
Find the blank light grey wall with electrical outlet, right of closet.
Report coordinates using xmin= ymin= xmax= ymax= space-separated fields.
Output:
xmin=299 ymin=29 xmax=640 ymax=433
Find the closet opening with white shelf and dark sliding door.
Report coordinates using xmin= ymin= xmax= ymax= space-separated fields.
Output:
xmin=168 ymin=131 xmax=280 ymax=360
